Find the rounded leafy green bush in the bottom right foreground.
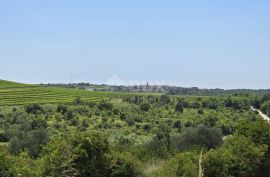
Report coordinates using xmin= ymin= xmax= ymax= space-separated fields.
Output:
xmin=204 ymin=136 xmax=267 ymax=177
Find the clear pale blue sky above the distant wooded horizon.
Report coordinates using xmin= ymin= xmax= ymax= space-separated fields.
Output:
xmin=0 ymin=0 xmax=270 ymax=89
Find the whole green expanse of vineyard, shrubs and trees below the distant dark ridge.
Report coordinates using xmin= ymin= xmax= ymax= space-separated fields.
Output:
xmin=0 ymin=82 xmax=270 ymax=177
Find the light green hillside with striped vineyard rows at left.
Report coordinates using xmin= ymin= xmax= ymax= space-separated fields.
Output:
xmin=0 ymin=80 xmax=113 ymax=106
